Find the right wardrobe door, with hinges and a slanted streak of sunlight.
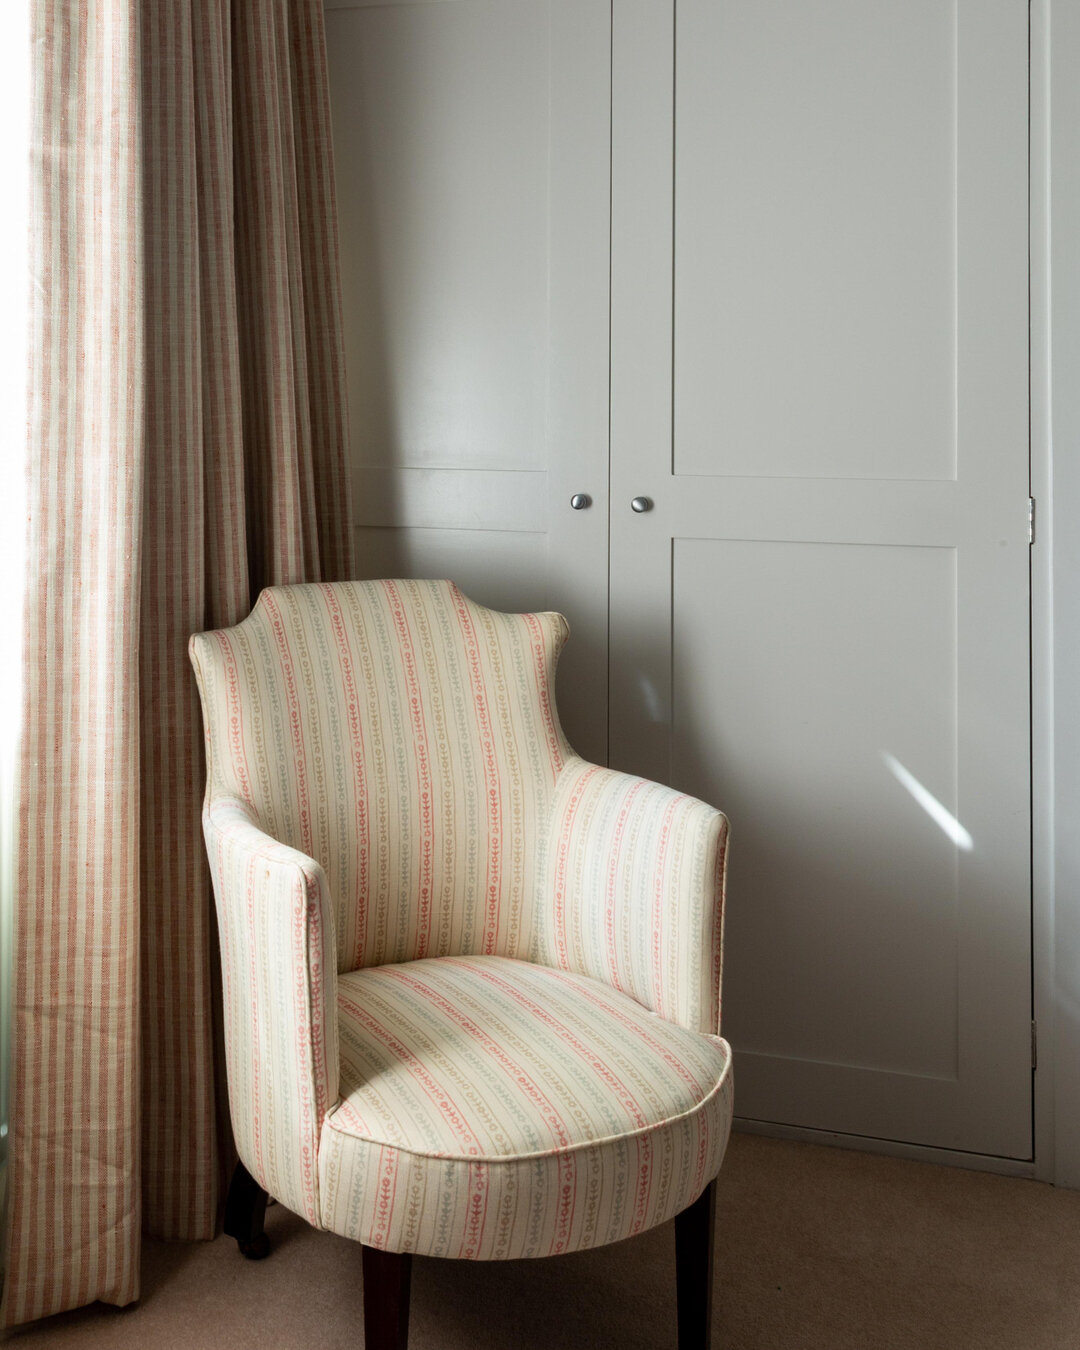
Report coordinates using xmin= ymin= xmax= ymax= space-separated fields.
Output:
xmin=612 ymin=0 xmax=1031 ymax=1158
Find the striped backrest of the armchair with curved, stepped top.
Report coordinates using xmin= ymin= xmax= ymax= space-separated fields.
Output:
xmin=192 ymin=581 xmax=572 ymax=971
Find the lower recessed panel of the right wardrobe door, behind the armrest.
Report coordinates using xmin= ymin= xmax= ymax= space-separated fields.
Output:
xmin=672 ymin=539 xmax=964 ymax=1077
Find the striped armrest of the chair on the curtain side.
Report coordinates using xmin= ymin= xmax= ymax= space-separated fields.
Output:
xmin=203 ymin=798 xmax=339 ymax=1227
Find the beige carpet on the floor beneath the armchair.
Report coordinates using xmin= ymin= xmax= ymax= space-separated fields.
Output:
xmin=11 ymin=1135 xmax=1080 ymax=1350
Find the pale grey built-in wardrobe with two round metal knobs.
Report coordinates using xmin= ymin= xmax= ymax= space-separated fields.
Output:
xmin=327 ymin=0 xmax=1033 ymax=1166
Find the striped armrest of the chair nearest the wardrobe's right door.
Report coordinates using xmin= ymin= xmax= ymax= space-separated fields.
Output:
xmin=540 ymin=759 xmax=728 ymax=1035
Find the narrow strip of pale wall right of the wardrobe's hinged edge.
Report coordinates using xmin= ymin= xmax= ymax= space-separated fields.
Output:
xmin=1031 ymin=0 xmax=1080 ymax=1188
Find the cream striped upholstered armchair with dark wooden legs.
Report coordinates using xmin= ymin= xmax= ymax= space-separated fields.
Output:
xmin=190 ymin=581 xmax=732 ymax=1350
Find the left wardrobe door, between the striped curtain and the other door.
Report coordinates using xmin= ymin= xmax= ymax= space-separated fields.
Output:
xmin=327 ymin=0 xmax=610 ymax=760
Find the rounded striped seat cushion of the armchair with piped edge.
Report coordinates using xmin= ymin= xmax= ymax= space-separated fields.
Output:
xmin=319 ymin=956 xmax=732 ymax=1260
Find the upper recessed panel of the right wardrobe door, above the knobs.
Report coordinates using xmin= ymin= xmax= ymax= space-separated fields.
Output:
xmin=675 ymin=0 xmax=957 ymax=479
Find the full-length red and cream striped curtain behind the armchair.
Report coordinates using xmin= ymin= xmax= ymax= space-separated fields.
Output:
xmin=0 ymin=0 xmax=350 ymax=1326
